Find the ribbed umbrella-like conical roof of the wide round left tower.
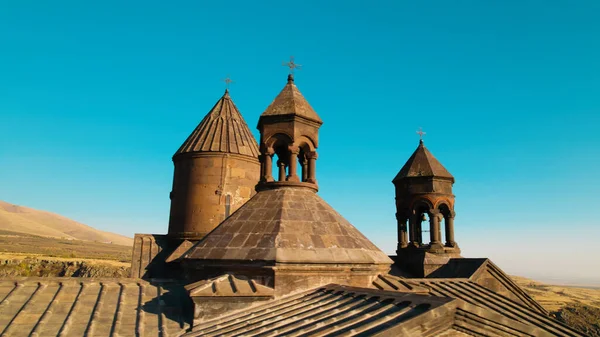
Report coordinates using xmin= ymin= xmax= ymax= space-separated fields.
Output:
xmin=175 ymin=90 xmax=259 ymax=158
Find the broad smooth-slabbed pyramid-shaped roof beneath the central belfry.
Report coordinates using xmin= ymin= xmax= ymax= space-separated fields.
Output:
xmin=185 ymin=187 xmax=392 ymax=264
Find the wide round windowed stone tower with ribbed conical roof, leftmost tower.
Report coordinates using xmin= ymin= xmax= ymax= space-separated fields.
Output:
xmin=169 ymin=86 xmax=260 ymax=240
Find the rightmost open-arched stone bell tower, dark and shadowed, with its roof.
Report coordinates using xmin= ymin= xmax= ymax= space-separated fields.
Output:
xmin=392 ymin=131 xmax=460 ymax=276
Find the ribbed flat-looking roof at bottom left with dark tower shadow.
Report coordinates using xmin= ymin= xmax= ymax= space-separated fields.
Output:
xmin=0 ymin=278 xmax=193 ymax=337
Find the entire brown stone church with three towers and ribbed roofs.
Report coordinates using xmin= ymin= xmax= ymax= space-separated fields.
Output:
xmin=0 ymin=69 xmax=582 ymax=337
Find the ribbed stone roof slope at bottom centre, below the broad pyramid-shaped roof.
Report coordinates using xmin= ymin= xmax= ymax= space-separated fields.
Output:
xmin=184 ymin=285 xmax=456 ymax=337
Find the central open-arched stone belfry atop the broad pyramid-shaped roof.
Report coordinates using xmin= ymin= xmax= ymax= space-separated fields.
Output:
xmin=256 ymin=72 xmax=323 ymax=190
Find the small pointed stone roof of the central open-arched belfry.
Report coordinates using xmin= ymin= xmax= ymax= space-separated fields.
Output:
xmin=260 ymin=75 xmax=323 ymax=123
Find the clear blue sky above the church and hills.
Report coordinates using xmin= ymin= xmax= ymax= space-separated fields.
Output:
xmin=0 ymin=0 xmax=600 ymax=283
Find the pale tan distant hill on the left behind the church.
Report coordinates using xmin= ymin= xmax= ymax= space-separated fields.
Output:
xmin=0 ymin=201 xmax=133 ymax=246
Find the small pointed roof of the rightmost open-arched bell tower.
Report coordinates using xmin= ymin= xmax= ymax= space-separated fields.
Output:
xmin=393 ymin=140 xmax=454 ymax=182
